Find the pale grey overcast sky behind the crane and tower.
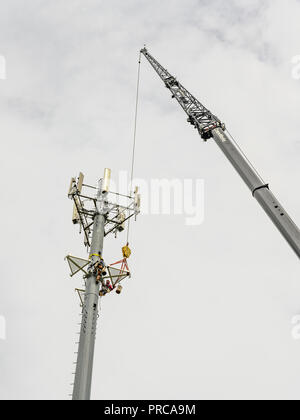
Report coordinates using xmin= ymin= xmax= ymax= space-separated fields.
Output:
xmin=0 ymin=0 xmax=300 ymax=399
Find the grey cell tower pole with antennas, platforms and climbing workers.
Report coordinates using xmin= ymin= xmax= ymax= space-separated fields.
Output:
xmin=66 ymin=169 xmax=140 ymax=400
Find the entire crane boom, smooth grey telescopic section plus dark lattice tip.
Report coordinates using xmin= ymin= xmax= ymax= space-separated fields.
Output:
xmin=141 ymin=48 xmax=300 ymax=258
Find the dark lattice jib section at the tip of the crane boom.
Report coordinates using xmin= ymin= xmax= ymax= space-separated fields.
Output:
xmin=141 ymin=48 xmax=225 ymax=140
